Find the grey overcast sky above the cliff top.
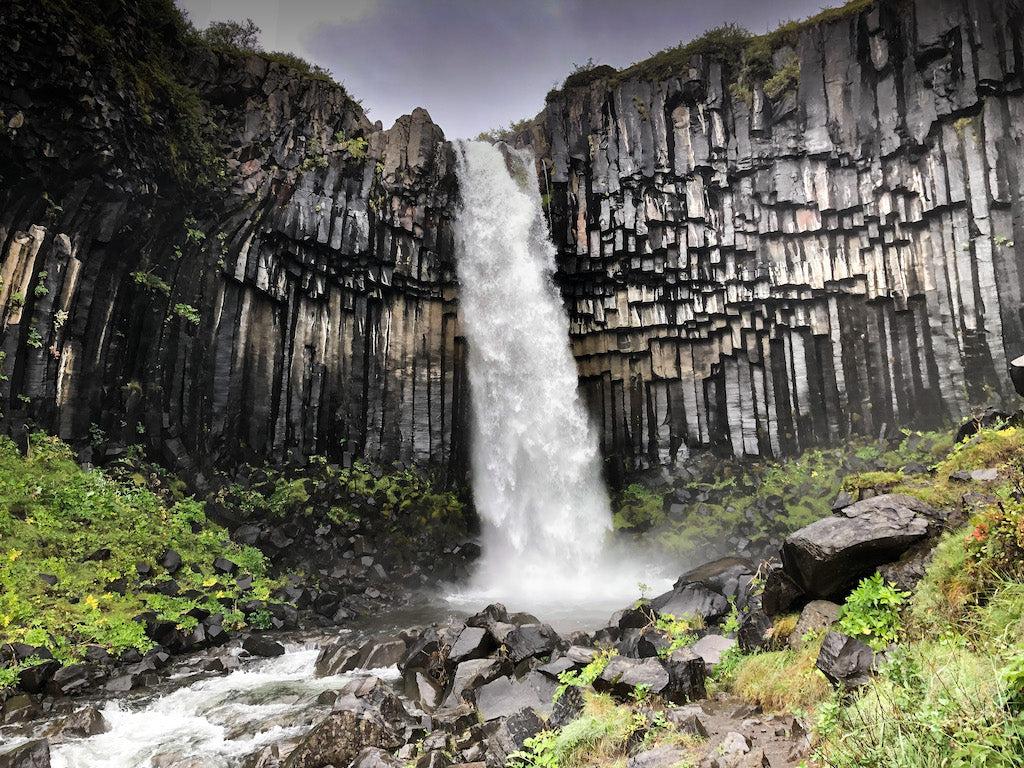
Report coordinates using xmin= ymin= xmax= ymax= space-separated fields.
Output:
xmin=176 ymin=0 xmax=842 ymax=138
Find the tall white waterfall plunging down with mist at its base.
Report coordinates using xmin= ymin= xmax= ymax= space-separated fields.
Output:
xmin=450 ymin=141 xmax=660 ymax=620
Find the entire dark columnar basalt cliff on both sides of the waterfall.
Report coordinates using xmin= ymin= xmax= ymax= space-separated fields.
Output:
xmin=0 ymin=0 xmax=1024 ymax=478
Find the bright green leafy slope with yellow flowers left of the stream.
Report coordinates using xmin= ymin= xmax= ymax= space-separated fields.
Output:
xmin=0 ymin=433 xmax=276 ymax=675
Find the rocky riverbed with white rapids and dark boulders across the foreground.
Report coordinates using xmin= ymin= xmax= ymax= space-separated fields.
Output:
xmin=0 ymin=487 xmax=949 ymax=768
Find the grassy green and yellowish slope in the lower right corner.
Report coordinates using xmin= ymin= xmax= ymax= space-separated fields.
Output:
xmin=696 ymin=427 xmax=1024 ymax=768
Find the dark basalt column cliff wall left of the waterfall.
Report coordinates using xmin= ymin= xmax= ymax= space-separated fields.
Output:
xmin=0 ymin=0 xmax=464 ymax=479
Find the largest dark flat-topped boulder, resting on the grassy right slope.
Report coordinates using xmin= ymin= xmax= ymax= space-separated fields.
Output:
xmin=782 ymin=494 xmax=942 ymax=599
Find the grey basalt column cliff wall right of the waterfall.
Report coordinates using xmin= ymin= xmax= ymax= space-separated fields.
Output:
xmin=518 ymin=0 xmax=1024 ymax=473
